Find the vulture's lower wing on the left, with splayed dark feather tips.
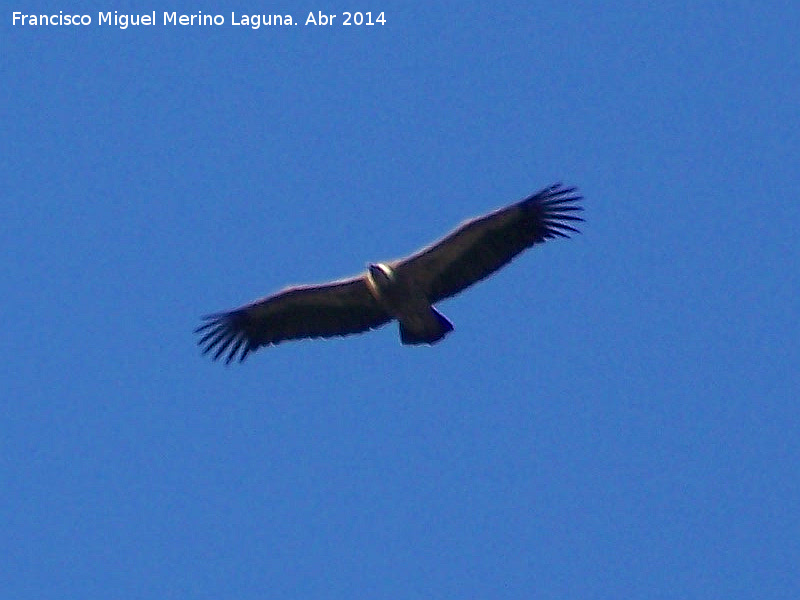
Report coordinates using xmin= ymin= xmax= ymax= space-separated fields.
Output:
xmin=195 ymin=277 xmax=391 ymax=363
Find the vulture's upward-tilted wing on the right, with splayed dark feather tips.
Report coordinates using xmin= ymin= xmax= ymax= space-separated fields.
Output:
xmin=393 ymin=183 xmax=583 ymax=304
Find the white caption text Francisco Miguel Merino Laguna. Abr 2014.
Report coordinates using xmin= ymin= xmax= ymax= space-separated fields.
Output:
xmin=12 ymin=10 xmax=386 ymax=29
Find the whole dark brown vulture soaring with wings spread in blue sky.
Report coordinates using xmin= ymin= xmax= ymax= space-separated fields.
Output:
xmin=195 ymin=183 xmax=583 ymax=363
